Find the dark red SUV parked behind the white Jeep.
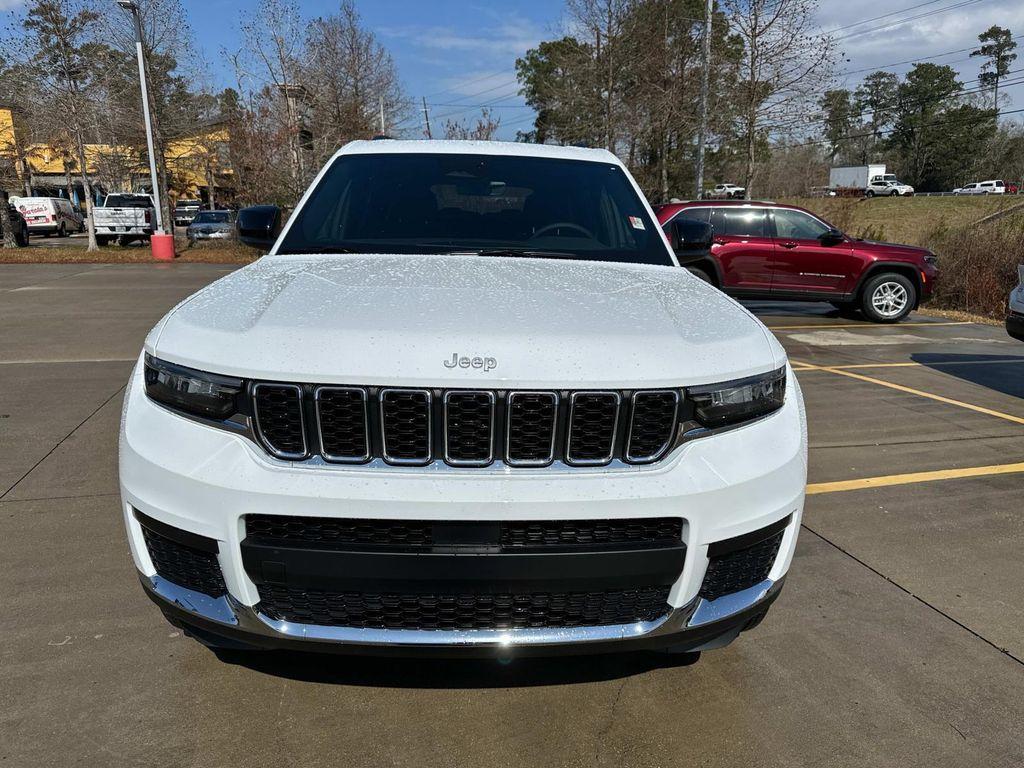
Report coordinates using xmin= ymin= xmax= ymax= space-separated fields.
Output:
xmin=654 ymin=201 xmax=938 ymax=323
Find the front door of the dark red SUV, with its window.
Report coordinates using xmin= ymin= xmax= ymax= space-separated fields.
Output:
xmin=769 ymin=208 xmax=857 ymax=294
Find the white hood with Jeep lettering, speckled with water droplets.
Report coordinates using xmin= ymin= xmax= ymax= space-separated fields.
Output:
xmin=150 ymin=255 xmax=781 ymax=388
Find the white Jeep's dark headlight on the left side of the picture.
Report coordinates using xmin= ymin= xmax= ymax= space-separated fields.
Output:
xmin=145 ymin=354 xmax=243 ymax=419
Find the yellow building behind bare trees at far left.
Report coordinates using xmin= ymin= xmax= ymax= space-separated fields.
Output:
xmin=0 ymin=105 xmax=234 ymax=203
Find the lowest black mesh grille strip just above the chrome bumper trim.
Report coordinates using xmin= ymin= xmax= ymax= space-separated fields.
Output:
xmin=259 ymin=585 xmax=670 ymax=630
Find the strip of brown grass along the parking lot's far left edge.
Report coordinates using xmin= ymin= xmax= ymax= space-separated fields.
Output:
xmin=0 ymin=238 xmax=261 ymax=264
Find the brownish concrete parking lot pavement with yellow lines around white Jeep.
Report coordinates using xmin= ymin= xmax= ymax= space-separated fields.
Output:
xmin=0 ymin=264 xmax=1024 ymax=768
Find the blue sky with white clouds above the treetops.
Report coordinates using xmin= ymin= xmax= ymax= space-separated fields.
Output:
xmin=99 ymin=0 xmax=1024 ymax=138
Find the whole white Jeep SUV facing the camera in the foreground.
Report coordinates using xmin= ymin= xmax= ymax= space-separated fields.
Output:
xmin=120 ymin=140 xmax=807 ymax=656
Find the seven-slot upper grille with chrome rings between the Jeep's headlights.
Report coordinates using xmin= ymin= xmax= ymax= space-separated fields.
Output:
xmin=245 ymin=382 xmax=693 ymax=472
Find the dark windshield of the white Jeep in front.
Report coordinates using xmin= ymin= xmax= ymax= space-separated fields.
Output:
xmin=278 ymin=154 xmax=673 ymax=266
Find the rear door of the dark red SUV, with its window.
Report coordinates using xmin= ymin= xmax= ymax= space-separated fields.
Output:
xmin=711 ymin=205 xmax=774 ymax=294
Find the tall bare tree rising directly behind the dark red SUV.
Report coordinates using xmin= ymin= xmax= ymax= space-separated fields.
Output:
xmin=722 ymin=0 xmax=833 ymax=195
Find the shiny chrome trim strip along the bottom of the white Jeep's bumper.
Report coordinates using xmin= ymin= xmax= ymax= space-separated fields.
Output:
xmin=139 ymin=573 xmax=781 ymax=648
